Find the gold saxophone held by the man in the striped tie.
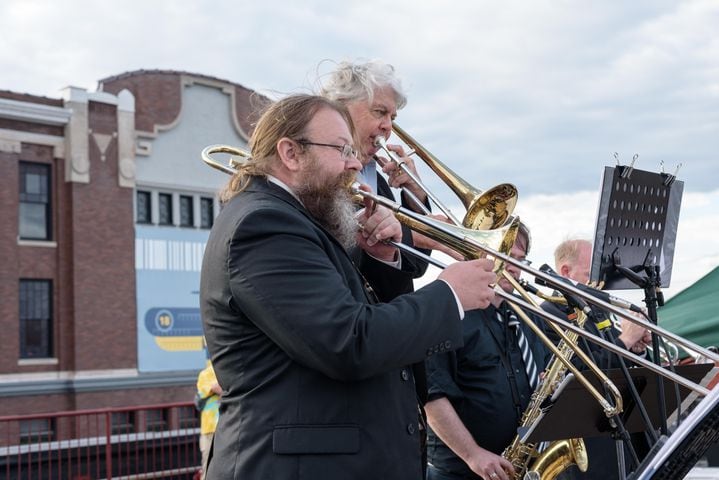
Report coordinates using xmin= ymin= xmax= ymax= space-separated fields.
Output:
xmin=502 ymin=311 xmax=589 ymax=480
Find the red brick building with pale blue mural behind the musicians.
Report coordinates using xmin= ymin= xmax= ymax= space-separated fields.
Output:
xmin=0 ymin=70 xmax=267 ymax=424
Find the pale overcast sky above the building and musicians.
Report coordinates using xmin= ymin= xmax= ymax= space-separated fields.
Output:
xmin=0 ymin=0 xmax=719 ymax=304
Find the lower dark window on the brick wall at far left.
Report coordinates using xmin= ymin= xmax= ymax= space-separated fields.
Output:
xmin=20 ymin=280 xmax=52 ymax=358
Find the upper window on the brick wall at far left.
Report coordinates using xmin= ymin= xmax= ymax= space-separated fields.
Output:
xmin=18 ymin=162 xmax=51 ymax=240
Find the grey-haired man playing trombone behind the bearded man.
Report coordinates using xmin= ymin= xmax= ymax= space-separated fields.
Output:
xmin=320 ymin=60 xmax=444 ymax=474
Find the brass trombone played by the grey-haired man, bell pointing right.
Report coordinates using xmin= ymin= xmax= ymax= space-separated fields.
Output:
xmin=375 ymin=123 xmax=517 ymax=230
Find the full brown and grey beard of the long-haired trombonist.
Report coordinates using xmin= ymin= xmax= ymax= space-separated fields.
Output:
xmin=295 ymin=166 xmax=357 ymax=250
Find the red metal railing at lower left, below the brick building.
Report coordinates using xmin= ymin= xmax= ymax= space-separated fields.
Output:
xmin=0 ymin=402 xmax=200 ymax=480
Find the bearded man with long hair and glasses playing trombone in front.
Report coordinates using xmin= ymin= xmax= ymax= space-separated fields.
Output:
xmin=200 ymin=95 xmax=495 ymax=480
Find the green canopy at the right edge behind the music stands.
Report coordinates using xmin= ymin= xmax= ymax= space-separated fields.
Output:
xmin=657 ymin=267 xmax=719 ymax=354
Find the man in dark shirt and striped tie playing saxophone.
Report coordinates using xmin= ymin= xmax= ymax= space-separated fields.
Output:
xmin=425 ymin=224 xmax=550 ymax=480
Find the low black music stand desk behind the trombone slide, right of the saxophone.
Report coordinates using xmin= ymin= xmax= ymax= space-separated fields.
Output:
xmin=527 ymin=363 xmax=714 ymax=443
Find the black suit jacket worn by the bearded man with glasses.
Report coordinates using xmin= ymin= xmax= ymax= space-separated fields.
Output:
xmin=200 ymin=178 xmax=462 ymax=480
